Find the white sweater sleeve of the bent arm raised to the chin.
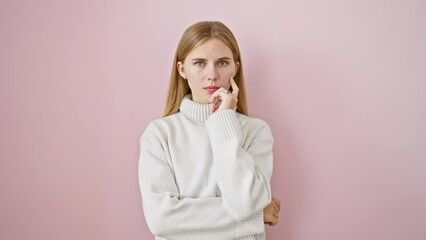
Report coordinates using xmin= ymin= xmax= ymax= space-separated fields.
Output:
xmin=206 ymin=110 xmax=274 ymax=221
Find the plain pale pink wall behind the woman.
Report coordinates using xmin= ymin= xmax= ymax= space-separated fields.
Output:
xmin=0 ymin=0 xmax=426 ymax=240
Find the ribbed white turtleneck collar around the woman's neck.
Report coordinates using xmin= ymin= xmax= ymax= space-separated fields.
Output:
xmin=179 ymin=94 xmax=211 ymax=123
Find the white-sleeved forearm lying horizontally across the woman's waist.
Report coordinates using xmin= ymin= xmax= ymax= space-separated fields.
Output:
xmin=143 ymin=194 xmax=264 ymax=240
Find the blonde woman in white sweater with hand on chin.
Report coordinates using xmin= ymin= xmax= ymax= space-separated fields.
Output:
xmin=139 ymin=22 xmax=280 ymax=240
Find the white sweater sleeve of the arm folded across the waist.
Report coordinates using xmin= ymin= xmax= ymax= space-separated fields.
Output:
xmin=139 ymin=124 xmax=264 ymax=240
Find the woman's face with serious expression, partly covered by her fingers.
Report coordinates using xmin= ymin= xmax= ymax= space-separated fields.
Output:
xmin=177 ymin=38 xmax=239 ymax=103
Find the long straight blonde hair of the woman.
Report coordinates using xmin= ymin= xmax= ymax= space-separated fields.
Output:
xmin=163 ymin=21 xmax=248 ymax=117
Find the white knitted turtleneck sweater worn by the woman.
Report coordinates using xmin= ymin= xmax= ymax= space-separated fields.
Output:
xmin=139 ymin=95 xmax=273 ymax=240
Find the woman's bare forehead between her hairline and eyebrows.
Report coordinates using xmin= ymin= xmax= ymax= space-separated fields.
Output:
xmin=188 ymin=38 xmax=232 ymax=59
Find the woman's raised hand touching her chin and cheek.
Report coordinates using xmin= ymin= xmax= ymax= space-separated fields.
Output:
xmin=209 ymin=76 xmax=240 ymax=112
